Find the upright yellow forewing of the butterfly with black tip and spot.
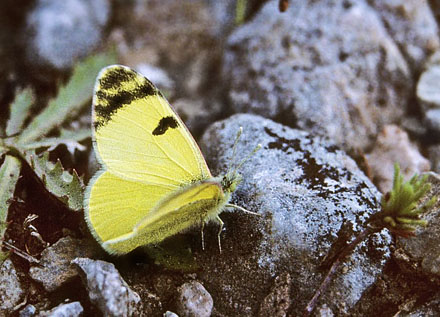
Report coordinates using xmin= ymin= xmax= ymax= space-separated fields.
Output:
xmin=93 ymin=66 xmax=211 ymax=187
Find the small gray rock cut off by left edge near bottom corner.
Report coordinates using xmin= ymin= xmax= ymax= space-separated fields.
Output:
xmin=0 ymin=259 xmax=24 ymax=316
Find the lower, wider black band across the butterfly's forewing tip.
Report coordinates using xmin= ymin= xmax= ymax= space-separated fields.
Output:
xmin=95 ymin=81 xmax=159 ymax=130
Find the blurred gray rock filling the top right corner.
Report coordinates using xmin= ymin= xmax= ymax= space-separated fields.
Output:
xmin=368 ymin=0 xmax=440 ymax=72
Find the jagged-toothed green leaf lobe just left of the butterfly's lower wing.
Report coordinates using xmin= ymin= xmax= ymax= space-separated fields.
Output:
xmin=26 ymin=152 xmax=84 ymax=210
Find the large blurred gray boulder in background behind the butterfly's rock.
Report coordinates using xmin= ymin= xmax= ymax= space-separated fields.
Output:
xmin=224 ymin=0 xmax=413 ymax=149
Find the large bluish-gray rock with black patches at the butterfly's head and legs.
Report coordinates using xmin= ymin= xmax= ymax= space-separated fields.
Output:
xmin=196 ymin=114 xmax=391 ymax=316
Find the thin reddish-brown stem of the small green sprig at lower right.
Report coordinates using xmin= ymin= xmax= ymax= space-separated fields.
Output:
xmin=303 ymin=226 xmax=382 ymax=317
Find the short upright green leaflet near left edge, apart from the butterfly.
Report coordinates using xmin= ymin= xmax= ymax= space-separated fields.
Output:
xmin=6 ymin=88 xmax=34 ymax=136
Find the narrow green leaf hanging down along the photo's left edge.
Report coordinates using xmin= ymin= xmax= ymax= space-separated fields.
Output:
xmin=0 ymin=155 xmax=21 ymax=263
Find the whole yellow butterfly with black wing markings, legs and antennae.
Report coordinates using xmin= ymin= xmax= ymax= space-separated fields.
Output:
xmin=84 ymin=65 xmax=259 ymax=254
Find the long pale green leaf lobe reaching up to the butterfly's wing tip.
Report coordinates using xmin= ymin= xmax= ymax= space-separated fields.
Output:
xmin=18 ymin=54 xmax=115 ymax=146
